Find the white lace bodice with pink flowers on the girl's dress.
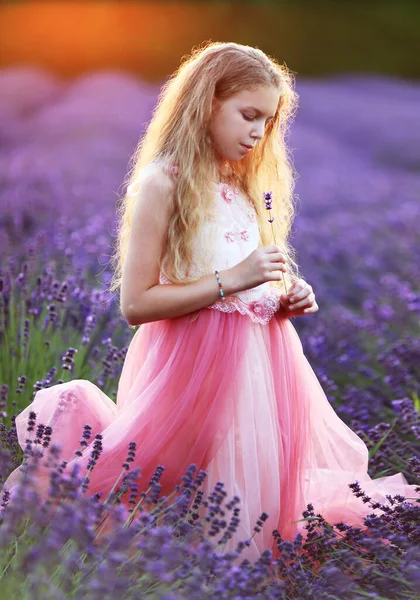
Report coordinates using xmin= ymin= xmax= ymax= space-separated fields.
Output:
xmin=130 ymin=165 xmax=281 ymax=324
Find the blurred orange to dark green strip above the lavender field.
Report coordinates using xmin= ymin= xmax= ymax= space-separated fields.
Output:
xmin=0 ymin=0 xmax=420 ymax=82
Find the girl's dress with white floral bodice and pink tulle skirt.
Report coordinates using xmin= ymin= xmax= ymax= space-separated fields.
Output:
xmin=1 ymin=162 xmax=420 ymax=560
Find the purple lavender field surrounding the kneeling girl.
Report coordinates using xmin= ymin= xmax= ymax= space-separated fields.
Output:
xmin=0 ymin=69 xmax=420 ymax=600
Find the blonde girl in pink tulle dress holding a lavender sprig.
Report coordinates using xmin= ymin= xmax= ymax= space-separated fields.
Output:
xmin=5 ymin=43 xmax=415 ymax=559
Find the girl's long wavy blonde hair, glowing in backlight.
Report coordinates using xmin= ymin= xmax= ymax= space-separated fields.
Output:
xmin=110 ymin=42 xmax=300 ymax=300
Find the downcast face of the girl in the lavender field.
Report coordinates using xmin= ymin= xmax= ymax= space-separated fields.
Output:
xmin=209 ymin=86 xmax=280 ymax=161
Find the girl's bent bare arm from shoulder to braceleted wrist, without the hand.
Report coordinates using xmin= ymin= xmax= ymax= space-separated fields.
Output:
xmin=121 ymin=167 xmax=243 ymax=325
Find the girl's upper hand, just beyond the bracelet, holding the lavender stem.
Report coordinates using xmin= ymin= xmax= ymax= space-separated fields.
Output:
xmin=232 ymin=245 xmax=287 ymax=290
